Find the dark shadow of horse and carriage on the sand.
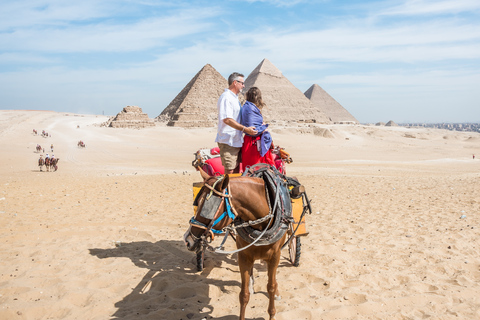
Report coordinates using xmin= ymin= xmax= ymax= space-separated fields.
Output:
xmin=90 ymin=240 xmax=246 ymax=320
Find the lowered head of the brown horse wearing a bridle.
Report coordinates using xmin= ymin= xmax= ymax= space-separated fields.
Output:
xmin=183 ymin=167 xmax=231 ymax=251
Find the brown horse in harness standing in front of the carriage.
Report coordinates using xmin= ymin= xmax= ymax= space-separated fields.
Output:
xmin=184 ymin=168 xmax=286 ymax=320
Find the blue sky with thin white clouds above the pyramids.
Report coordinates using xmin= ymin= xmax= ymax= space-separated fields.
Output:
xmin=0 ymin=0 xmax=480 ymax=123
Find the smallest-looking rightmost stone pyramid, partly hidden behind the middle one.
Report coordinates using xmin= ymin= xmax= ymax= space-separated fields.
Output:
xmin=305 ymin=84 xmax=358 ymax=123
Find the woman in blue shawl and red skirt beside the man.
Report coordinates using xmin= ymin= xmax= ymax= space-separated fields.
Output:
xmin=241 ymin=87 xmax=275 ymax=168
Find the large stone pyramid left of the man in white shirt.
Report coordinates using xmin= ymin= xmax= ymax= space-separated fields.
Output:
xmin=156 ymin=64 xmax=228 ymax=128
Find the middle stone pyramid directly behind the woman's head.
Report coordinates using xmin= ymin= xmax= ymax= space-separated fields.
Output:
xmin=243 ymin=59 xmax=331 ymax=123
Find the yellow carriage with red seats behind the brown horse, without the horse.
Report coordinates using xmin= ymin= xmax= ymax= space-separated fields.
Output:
xmin=188 ymin=146 xmax=311 ymax=271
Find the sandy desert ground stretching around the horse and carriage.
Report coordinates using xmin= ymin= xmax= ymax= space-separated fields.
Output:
xmin=0 ymin=110 xmax=480 ymax=320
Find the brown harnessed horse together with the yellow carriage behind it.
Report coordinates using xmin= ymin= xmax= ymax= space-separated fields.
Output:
xmin=184 ymin=148 xmax=312 ymax=320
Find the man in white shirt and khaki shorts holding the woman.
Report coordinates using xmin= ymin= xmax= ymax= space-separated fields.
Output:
xmin=215 ymin=72 xmax=258 ymax=174
